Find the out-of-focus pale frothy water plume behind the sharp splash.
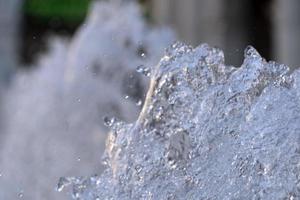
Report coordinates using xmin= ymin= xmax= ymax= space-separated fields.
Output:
xmin=0 ymin=1 xmax=174 ymax=200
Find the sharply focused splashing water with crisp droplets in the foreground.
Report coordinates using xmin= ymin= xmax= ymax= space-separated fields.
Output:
xmin=59 ymin=43 xmax=300 ymax=200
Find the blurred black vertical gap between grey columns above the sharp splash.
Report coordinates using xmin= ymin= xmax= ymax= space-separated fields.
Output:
xmin=225 ymin=0 xmax=274 ymax=66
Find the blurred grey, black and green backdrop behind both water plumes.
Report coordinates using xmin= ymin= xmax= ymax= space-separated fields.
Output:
xmin=0 ymin=0 xmax=300 ymax=79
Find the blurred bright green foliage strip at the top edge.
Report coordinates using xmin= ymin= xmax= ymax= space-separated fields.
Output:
xmin=24 ymin=0 xmax=91 ymax=23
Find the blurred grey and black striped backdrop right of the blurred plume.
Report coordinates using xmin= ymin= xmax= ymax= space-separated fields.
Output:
xmin=151 ymin=0 xmax=300 ymax=68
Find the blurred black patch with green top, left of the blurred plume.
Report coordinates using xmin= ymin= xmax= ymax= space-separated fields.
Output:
xmin=21 ymin=0 xmax=91 ymax=64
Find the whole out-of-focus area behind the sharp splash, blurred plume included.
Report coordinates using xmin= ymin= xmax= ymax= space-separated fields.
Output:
xmin=0 ymin=0 xmax=300 ymax=200
